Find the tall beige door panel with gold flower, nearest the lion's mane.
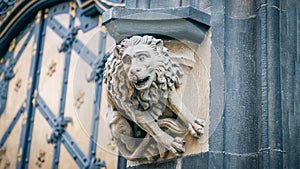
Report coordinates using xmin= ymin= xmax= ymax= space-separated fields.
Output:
xmin=64 ymin=51 xmax=93 ymax=154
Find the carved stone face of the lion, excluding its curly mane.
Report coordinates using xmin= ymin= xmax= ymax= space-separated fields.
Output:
xmin=121 ymin=45 xmax=161 ymax=90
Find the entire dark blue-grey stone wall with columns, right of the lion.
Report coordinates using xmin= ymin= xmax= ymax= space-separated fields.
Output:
xmin=103 ymin=0 xmax=300 ymax=168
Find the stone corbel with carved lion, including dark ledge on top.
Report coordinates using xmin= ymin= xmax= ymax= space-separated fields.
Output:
xmin=102 ymin=0 xmax=210 ymax=165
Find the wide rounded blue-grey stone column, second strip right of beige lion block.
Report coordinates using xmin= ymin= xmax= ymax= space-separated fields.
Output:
xmin=224 ymin=1 xmax=258 ymax=157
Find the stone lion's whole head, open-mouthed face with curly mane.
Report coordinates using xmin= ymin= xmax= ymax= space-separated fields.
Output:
xmin=104 ymin=36 xmax=183 ymax=110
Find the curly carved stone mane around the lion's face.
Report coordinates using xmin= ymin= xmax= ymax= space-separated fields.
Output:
xmin=104 ymin=36 xmax=183 ymax=116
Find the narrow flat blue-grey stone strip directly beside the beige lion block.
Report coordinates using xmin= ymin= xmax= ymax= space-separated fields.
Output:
xmin=209 ymin=0 xmax=225 ymax=153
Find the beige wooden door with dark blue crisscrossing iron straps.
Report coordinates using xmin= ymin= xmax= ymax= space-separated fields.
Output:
xmin=0 ymin=1 xmax=125 ymax=168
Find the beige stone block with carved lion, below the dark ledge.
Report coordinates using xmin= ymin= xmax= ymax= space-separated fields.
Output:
xmin=104 ymin=35 xmax=211 ymax=166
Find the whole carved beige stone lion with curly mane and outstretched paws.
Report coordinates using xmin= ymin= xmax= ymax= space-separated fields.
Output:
xmin=104 ymin=36 xmax=204 ymax=161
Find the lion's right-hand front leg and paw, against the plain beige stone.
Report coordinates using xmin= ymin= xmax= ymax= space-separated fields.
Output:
xmin=168 ymin=89 xmax=205 ymax=138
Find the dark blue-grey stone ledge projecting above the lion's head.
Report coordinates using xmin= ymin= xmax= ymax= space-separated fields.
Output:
xmin=103 ymin=7 xmax=210 ymax=44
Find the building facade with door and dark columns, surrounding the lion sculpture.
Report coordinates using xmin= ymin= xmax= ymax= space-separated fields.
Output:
xmin=0 ymin=0 xmax=300 ymax=169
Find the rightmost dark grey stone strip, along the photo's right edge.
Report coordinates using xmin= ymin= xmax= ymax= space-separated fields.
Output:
xmin=273 ymin=0 xmax=300 ymax=168
